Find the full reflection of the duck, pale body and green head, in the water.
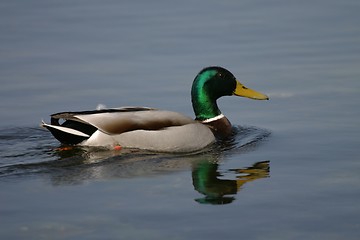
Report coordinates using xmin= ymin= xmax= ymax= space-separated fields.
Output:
xmin=45 ymin=146 xmax=270 ymax=204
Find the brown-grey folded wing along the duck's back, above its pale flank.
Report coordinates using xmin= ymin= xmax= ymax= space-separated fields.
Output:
xmin=47 ymin=107 xmax=194 ymax=135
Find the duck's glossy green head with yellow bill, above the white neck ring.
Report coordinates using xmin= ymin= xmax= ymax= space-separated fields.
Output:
xmin=191 ymin=67 xmax=269 ymax=121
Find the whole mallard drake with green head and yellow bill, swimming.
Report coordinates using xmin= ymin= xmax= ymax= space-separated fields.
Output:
xmin=41 ymin=67 xmax=269 ymax=152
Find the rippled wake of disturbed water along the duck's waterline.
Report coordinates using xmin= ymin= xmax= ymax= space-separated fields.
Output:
xmin=0 ymin=126 xmax=270 ymax=181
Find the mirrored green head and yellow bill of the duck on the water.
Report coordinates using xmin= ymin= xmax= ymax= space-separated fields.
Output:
xmin=192 ymin=161 xmax=270 ymax=204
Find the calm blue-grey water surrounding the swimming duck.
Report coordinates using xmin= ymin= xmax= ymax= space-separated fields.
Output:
xmin=0 ymin=0 xmax=360 ymax=239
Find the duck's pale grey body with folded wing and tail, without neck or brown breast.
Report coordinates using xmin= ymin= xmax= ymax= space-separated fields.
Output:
xmin=42 ymin=108 xmax=215 ymax=152
